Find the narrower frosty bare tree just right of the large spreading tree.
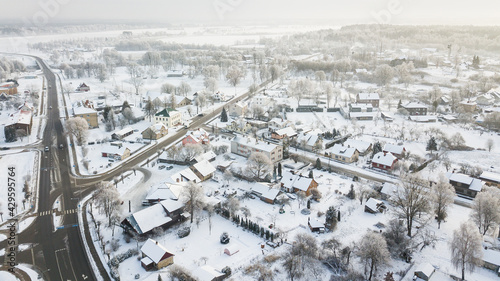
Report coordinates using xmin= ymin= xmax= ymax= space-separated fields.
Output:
xmin=431 ymin=175 xmax=456 ymax=229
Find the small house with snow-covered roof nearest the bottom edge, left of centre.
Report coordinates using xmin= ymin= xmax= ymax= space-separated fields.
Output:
xmin=141 ymin=238 xmax=174 ymax=270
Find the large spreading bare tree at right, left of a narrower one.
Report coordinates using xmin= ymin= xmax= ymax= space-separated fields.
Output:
xmin=391 ymin=174 xmax=429 ymax=237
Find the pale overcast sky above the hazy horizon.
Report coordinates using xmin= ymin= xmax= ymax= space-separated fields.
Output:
xmin=6 ymin=0 xmax=500 ymax=25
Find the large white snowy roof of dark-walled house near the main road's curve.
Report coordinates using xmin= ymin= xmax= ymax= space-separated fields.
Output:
xmin=127 ymin=204 xmax=172 ymax=234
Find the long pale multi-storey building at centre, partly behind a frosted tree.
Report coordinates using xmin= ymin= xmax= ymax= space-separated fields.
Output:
xmin=231 ymin=136 xmax=283 ymax=163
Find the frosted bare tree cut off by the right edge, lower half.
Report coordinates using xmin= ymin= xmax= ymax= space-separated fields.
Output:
xmin=471 ymin=187 xmax=500 ymax=235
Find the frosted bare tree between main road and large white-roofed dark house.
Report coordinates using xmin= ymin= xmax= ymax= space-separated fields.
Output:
xmin=93 ymin=181 xmax=121 ymax=226
